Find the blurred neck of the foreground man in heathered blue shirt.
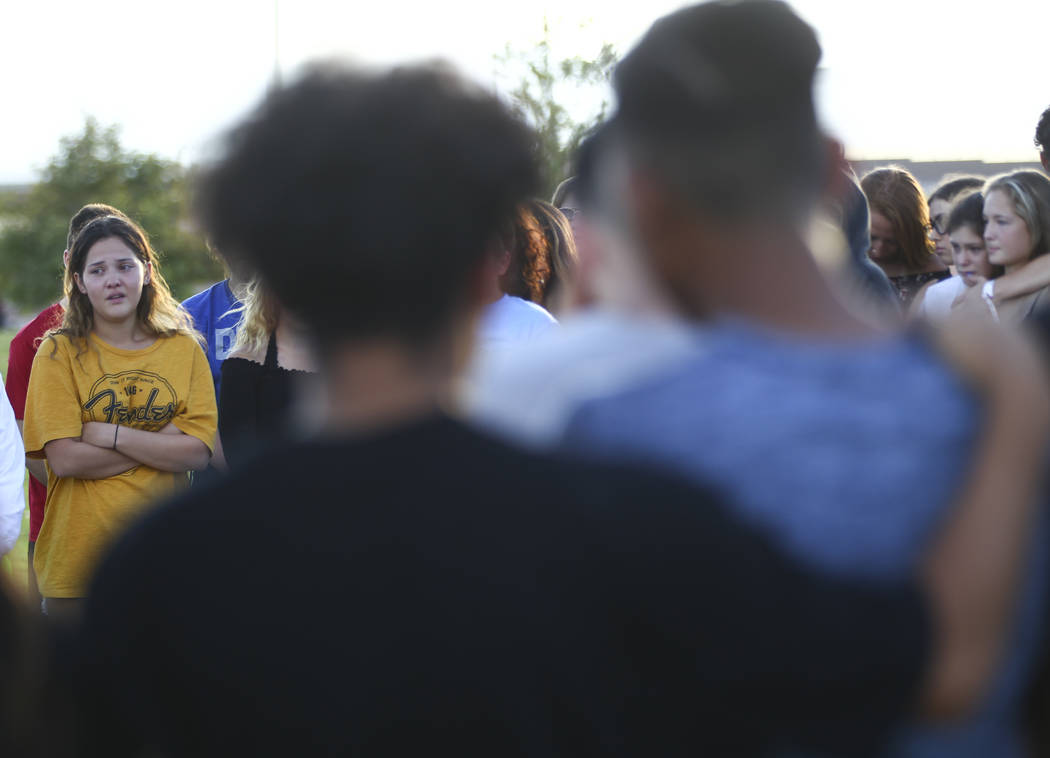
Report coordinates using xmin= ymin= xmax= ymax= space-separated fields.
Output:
xmin=679 ymin=218 xmax=882 ymax=337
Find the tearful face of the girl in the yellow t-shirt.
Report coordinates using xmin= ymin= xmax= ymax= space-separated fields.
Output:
xmin=74 ymin=237 xmax=150 ymax=323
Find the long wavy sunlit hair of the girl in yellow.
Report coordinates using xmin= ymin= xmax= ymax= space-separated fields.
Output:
xmin=48 ymin=215 xmax=202 ymax=355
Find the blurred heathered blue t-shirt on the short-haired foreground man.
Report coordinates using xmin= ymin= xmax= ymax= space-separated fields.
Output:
xmin=564 ymin=321 xmax=1047 ymax=756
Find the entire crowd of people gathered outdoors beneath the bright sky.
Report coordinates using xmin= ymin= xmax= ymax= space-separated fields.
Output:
xmin=0 ymin=0 xmax=1050 ymax=758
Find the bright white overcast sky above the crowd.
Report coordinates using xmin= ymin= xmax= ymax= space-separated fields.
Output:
xmin=0 ymin=0 xmax=1050 ymax=184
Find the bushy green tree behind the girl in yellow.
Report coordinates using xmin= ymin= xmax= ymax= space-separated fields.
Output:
xmin=0 ymin=118 xmax=223 ymax=309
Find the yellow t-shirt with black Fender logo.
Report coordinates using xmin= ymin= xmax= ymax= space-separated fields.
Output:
xmin=23 ymin=335 xmax=216 ymax=597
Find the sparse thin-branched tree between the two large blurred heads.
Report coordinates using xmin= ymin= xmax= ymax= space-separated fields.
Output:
xmin=496 ymin=24 xmax=617 ymax=197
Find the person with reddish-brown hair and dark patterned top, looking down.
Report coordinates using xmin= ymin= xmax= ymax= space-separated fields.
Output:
xmin=860 ymin=167 xmax=951 ymax=310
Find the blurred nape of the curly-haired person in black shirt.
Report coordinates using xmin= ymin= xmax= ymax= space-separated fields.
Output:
xmin=319 ymin=339 xmax=455 ymax=435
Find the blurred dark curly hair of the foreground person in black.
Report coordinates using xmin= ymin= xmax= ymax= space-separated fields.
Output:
xmin=197 ymin=64 xmax=537 ymax=348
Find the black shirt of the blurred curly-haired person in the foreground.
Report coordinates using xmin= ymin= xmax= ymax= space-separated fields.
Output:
xmin=79 ymin=417 xmax=927 ymax=756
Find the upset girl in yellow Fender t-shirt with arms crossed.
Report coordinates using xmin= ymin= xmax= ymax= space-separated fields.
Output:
xmin=24 ymin=216 xmax=216 ymax=615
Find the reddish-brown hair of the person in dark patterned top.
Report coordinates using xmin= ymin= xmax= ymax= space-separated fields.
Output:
xmin=860 ymin=166 xmax=933 ymax=269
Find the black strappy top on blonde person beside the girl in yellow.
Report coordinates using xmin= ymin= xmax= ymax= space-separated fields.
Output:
xmin=218 ymin=332 xmax=309 ymax=469
